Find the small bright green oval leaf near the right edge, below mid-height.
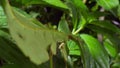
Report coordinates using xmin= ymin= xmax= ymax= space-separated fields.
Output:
xmin=104 ymin=39 xmax=117 ymax=57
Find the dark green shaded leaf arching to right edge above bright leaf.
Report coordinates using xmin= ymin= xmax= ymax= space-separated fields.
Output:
xmin=87 ymin=22 xmax=120 ymax=50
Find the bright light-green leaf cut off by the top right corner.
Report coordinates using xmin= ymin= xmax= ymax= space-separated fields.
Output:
xmin=96 ymin=0 xmax=119 ymax=10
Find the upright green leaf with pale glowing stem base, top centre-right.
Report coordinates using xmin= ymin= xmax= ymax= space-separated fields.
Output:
xmin=67 ymin=0 xmax=88 ymax=34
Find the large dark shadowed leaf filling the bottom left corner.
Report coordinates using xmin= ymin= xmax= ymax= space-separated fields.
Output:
xmin=0 ymin=36 xmax=36 ymax=68
